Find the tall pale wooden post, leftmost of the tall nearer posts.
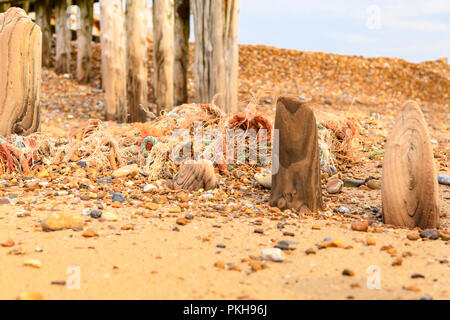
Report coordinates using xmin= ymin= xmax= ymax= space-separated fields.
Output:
xmin=100 ymin=0 xmax=128 ymax=122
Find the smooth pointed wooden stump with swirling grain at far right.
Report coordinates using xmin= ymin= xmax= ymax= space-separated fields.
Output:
xmin=381 ymin=101 xmax=439 ymax=229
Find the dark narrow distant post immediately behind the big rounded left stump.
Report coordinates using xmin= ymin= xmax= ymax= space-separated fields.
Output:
xmin=34 ymin=0 xmax=52 ymax=68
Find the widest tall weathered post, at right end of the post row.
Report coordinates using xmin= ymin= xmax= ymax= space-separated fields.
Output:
xmin=191 ymin=0 xmax=240 ymax=113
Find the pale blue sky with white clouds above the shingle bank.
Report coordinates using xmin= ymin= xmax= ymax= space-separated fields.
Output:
xmin=121 ymin=0 xmax=450 ymax=62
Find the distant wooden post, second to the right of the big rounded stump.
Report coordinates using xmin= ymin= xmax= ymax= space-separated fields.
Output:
xmin=55 ymin=0 xmax=72 ymax=74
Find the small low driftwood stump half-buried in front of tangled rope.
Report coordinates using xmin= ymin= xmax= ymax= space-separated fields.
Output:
xmin=167 ymin=160 xmax=218 ymax=191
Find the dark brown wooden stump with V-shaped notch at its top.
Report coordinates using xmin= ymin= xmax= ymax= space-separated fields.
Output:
xmin=270 ymin=97 xmax=323 ymax=212
